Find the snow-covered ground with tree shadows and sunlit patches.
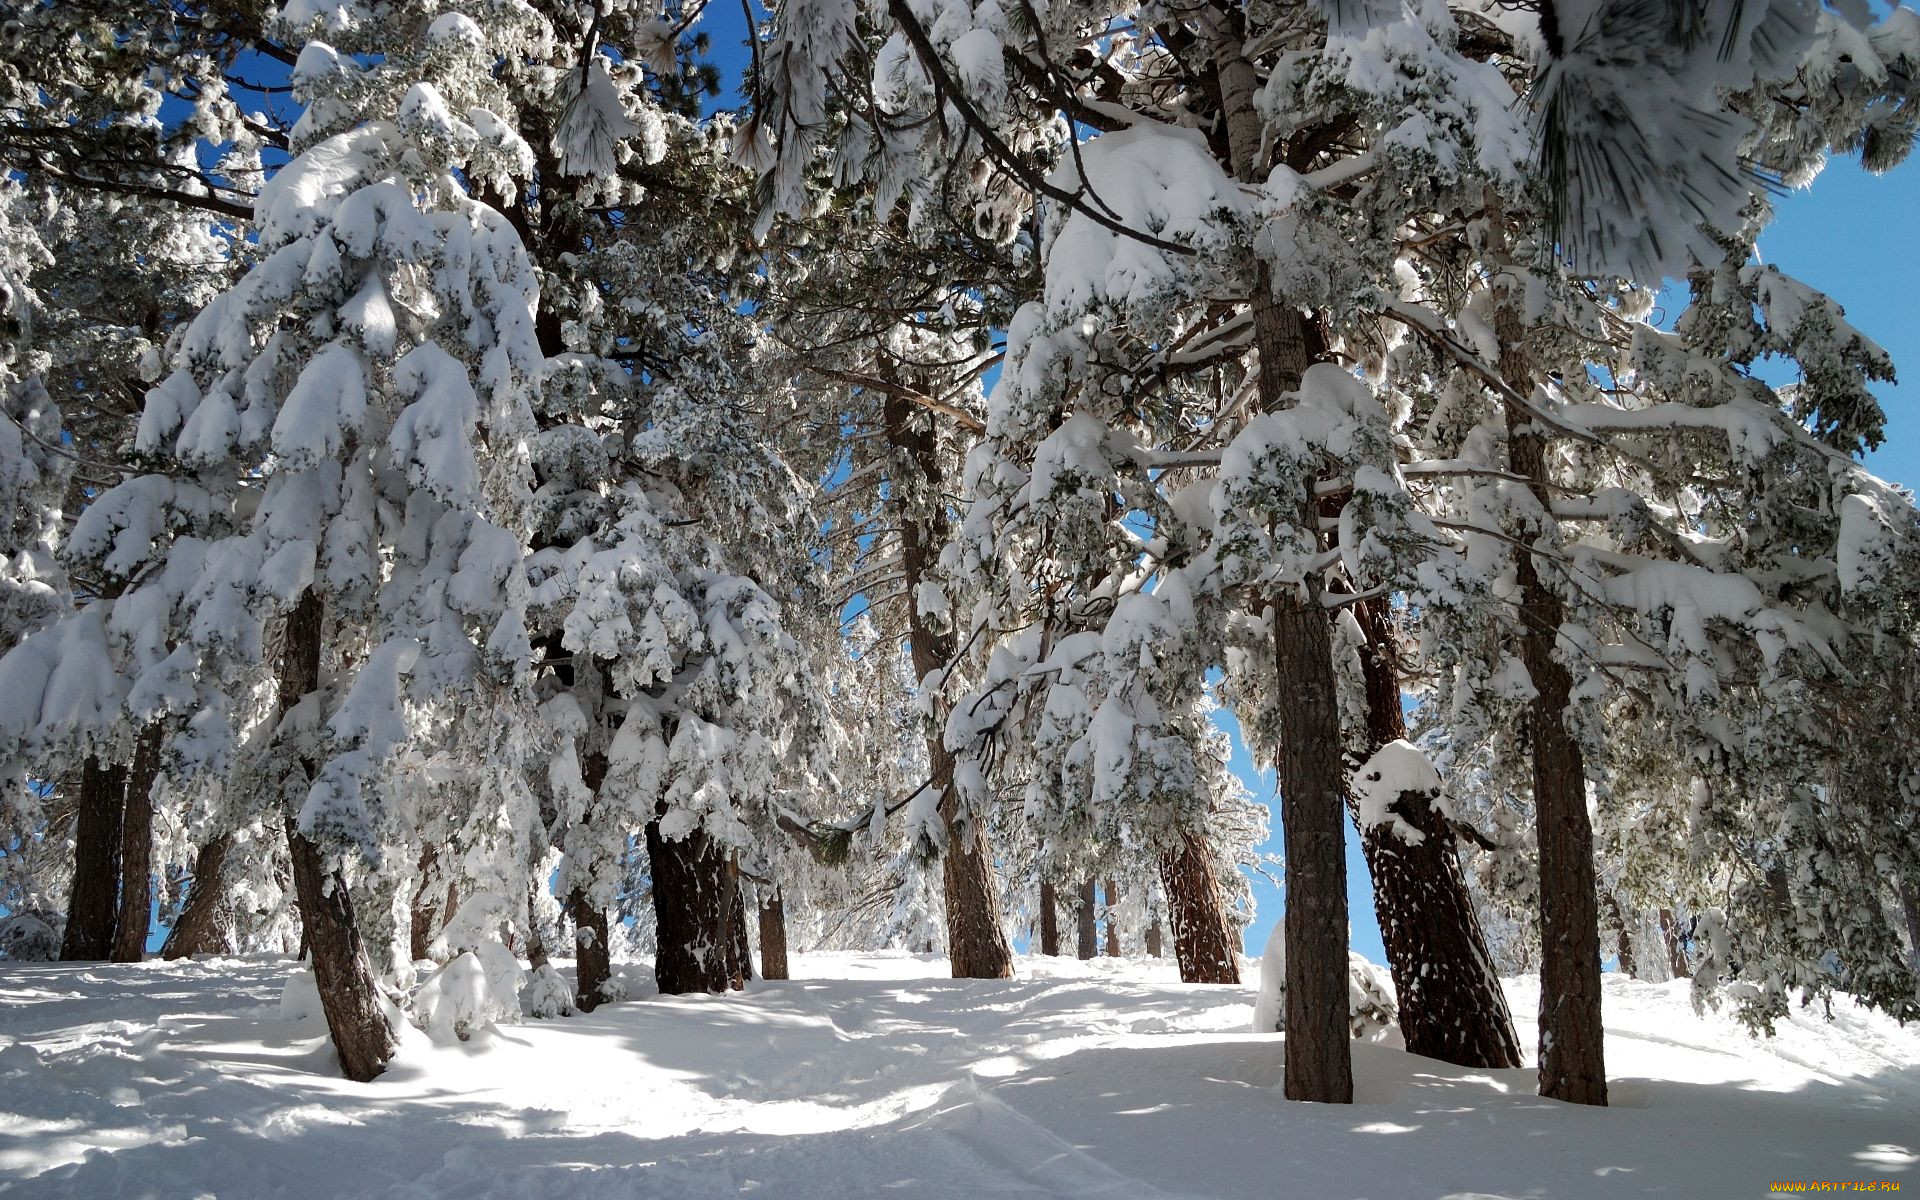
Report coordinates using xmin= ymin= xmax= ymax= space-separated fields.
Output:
xmin=0 ymin=954 xmax=1920 ymax=1200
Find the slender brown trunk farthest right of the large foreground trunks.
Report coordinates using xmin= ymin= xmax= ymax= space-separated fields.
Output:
xmin=1494 ymin=280 xmax=1607 ymax=1104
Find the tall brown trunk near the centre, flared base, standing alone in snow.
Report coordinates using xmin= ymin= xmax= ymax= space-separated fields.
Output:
xmin=883 ymin=378 xmax=1014 ymax=979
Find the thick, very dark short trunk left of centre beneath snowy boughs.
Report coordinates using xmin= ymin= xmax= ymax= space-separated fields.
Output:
xmin=647 ymin=820 xmax=751 ymax=993
